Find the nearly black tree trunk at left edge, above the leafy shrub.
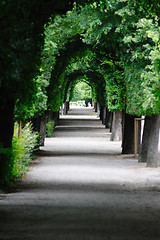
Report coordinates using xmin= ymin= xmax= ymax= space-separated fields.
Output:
xmin=0 ymin=99 xmax=15 ymax=148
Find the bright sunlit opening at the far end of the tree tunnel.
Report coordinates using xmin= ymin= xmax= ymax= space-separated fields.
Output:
xmin=70 ymin=80 xmax=92 ymax=107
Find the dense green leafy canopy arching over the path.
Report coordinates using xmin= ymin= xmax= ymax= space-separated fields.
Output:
xmin=1 ymin=0 xmax=160 ymax=122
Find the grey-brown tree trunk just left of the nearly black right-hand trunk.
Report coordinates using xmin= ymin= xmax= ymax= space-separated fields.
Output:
xmin=110 ymin=111 xmax=122 ymax=141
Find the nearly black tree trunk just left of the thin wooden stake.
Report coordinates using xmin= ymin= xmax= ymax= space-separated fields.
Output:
xmin=122 ymin=113 xmax=135 ymax=154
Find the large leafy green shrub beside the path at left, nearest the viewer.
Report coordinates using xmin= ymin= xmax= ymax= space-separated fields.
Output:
xmin=0 ymin=123 xmax=38 ymax=186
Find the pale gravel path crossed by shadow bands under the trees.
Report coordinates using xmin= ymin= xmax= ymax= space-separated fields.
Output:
xmin=0 ymin=108 xmax=160 ymax=240
